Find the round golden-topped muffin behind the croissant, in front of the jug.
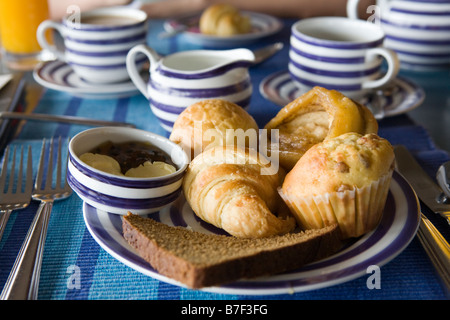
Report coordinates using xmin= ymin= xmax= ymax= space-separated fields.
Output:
xmin=169 ymin=99 xmax=259 ymax=159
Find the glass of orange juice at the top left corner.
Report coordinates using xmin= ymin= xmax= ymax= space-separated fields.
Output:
xmin=0 ymin=0 xmax=49 ymax=54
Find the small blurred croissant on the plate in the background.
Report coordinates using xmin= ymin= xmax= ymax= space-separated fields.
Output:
xmin=199 ymin=4 xmax=251 ymax=37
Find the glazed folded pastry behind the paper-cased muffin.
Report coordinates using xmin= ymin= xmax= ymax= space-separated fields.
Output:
xmin=265 ymin=87 xmax=378 ymax=170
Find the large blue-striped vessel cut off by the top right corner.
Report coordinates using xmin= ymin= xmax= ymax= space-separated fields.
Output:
xmin=347 ymin=0 xmax=450 ymax=70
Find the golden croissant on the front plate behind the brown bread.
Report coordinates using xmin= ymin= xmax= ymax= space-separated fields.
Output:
xmin=183 ymin=146 xmax=295 ymax=238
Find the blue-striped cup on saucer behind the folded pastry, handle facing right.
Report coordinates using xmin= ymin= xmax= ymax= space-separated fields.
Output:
xmin=289 ymin=17 xmax=399 ymax=99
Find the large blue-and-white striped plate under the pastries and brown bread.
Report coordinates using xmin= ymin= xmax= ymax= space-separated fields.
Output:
xmin=83 ymin=172 xmax=419 ymax=295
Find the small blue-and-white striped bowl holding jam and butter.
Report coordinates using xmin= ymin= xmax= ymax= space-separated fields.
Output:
xmin=67 ymin=127 xmax=189 ymax=214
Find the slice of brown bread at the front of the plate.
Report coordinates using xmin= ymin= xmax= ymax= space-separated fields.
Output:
xmin=122 ymin=213 xmax=341 ymax=288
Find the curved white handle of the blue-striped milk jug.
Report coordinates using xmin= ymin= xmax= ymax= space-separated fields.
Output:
xmin=126 ymin=44 xmax=160 ymax=99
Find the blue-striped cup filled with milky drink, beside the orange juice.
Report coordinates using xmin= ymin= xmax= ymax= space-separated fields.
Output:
xmin=37 ymin=7 xmax=147 ymax=84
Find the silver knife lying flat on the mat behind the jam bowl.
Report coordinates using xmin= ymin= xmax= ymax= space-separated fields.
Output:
xmin=0 ymin=111 xmax=136 ymax=128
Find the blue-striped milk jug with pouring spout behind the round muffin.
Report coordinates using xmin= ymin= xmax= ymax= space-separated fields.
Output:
xmin=127 ymin=45 xmax=255 ymax=132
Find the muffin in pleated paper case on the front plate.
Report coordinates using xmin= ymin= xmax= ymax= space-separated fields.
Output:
xmin=279 ymin=132 xmax=395 ymax=239
